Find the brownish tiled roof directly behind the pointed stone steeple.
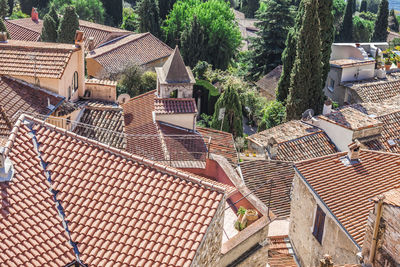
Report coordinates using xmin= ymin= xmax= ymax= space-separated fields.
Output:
xmin=86 ymin=33 xmax=172 ymax=73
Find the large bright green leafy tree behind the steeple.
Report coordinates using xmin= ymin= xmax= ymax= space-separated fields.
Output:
xmin=163 ymin=0 xmax=241 ymax=69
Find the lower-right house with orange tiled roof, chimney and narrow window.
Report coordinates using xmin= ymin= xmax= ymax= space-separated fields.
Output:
xmin=289 ymin=142 xmax=400 ymax=266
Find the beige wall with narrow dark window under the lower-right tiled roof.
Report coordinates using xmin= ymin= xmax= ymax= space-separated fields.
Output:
xmin=289 ymin=173 xmax=359 ymax=266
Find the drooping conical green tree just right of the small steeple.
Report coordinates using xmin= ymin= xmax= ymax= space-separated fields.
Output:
xmin=211 ymin=83 xmax=243 ymax=137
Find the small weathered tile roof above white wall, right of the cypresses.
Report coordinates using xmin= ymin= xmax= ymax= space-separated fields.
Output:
xmin=318 ymin=107 xmax=382 ymax=130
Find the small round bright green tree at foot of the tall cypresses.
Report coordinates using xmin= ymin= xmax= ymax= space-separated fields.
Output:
xmin=257 ymin=101 xmax=286 ymax=132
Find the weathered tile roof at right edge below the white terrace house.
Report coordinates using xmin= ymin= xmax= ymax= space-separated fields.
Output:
xmin=349 ymin=80 xmax=400 ymax=102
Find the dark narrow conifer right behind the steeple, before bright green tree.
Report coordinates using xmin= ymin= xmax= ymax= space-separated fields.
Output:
xmin=181 ymin=16 xmax=205 ymax=68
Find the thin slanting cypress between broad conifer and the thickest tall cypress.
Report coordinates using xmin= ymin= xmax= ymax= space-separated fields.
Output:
xmin=276 ymin=1 xmax=304 ymax=103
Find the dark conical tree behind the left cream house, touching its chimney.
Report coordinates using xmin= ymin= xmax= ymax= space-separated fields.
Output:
xmin=57 ymin=6 xmax=79 ymax=44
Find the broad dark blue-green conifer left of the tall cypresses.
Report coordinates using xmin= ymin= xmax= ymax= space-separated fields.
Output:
xmin=251 ymin=0 xmax=293 ymax=78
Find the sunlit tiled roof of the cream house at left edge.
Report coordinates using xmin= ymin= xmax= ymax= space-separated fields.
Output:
xmin=0 ymin=40 xmax=77 ymax=79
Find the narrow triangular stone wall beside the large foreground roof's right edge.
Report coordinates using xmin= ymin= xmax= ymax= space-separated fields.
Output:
xmin=192 ymin=197 xmax=226 ymax=266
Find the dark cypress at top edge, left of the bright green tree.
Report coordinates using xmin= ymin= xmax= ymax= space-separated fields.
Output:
xmin=137 ymin=0 xmax=161 ymax=37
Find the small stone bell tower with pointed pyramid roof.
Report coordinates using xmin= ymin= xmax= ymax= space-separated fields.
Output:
xmin=156 ymin=46 xmax=196 ymax=98
